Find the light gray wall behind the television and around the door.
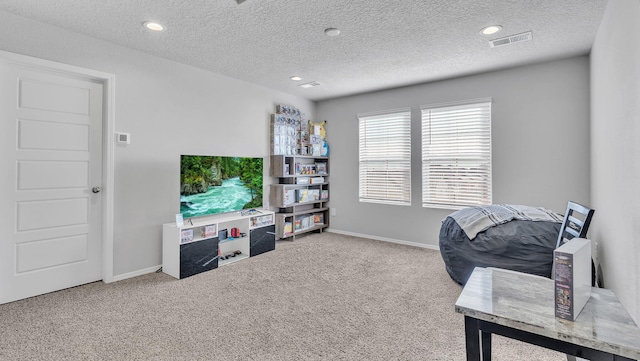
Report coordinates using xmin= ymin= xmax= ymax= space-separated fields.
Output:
xmin=0 ymin=12 xmax=315 ymax=278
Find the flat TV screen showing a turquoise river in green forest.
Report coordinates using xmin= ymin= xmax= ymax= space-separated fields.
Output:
xmin=180 ymin=155 xmax=263 ymax=218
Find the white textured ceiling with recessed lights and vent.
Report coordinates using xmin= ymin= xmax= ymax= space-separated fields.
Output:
xmin=0 ymin=0 xmax=607 ymax=100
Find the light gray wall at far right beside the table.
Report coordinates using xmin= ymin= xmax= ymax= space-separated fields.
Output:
xmin=591 ymin=0 xmax=640 ymax=324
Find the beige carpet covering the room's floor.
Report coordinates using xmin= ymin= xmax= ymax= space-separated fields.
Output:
xmin=0 ymin=233 xmax=566 ymax=361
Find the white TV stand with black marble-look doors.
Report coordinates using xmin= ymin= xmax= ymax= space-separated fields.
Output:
xmin=162 ymin=209 xmax=275 ymax=278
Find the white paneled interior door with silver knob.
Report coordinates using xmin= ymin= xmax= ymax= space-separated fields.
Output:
xmin=0 ymin=62 xmax=103 ymax=303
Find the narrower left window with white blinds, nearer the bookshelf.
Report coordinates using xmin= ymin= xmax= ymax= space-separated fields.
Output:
xmin=358 ymin=108 xmax=411 ymax=205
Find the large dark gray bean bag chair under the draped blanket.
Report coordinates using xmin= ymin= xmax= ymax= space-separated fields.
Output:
xmin=439 ymin=205 xmax=563 ymax=285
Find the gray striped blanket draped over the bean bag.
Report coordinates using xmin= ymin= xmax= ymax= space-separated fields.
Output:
xmin=449 ymin=204 xmax=564 ymax=240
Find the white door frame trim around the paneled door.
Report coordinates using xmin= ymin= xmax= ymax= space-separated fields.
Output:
xmin=0 ymin=50 xmax=116 ymax=283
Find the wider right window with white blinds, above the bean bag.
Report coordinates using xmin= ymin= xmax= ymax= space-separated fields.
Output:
xmin=420 ymin=99 xmax=491 ymax=209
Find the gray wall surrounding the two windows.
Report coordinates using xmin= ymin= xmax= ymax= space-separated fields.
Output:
xmin=317 ymin=56 xmax=590 ymax=246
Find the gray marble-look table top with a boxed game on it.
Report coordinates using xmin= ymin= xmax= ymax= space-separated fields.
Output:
xmin=455 ymin=267 xmax=640 ymax=360
